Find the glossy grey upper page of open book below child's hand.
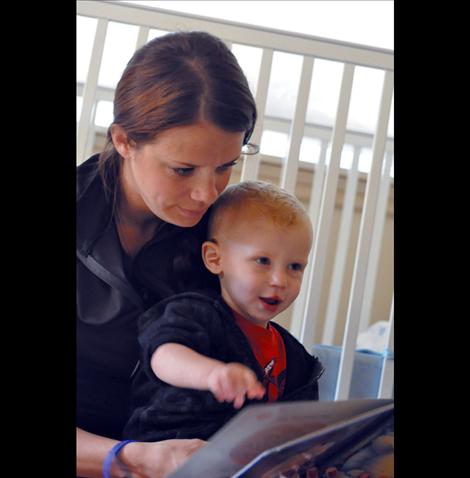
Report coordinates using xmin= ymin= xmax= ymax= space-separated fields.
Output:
xmin=171 ymin=399 xmax=393 ymax=478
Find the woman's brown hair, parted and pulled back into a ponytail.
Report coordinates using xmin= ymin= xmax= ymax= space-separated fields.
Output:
xmin=99 ymin=31 xmax=256 ymax=202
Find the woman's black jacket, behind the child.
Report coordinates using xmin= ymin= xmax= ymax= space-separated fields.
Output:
xmin=76 ymin=155 xmax=219 ymax=439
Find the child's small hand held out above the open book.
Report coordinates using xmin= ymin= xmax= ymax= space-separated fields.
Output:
xmin=207 ymin=363 xmax=264 ymax=408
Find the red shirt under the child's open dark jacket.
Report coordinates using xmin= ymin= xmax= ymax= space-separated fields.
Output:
xmin=233 ymin=311 xmax=286 ymax=402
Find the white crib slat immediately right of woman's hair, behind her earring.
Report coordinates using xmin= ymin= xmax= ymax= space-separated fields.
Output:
xmin=240 ymin=48 xmax=273 ymax=181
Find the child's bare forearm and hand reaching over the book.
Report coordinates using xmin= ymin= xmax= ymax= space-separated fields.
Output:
xmin=150 ymin=343 xmax=264 ymax=408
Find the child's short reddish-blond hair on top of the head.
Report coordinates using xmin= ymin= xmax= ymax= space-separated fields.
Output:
xmin=208 ymin=181 xmax=311 ymax=238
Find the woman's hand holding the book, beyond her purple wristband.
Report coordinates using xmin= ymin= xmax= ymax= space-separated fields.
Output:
xmin=119 ymin=439 xmax=206 ymax=478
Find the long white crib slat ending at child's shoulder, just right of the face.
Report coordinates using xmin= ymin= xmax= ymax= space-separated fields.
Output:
xmin=300 ymin=63 xmax=355 ymax=350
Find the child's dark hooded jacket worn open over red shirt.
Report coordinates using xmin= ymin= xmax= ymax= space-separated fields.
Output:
xmin=123 ymin=292 xmax=323 ymax=441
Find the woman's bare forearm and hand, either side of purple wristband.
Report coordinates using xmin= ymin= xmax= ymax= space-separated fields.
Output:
xmin=77 ymin=428 xmax=206 ymax=478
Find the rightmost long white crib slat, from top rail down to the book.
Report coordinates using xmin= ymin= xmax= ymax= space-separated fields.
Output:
xmin=335 ymin=72 xmax=393 ymax=400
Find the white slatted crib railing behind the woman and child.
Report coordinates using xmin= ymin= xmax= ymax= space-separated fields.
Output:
xmin=77 ymin=1 xmax=393 ymax=399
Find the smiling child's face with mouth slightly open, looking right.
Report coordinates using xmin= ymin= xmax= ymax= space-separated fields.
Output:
xmin=219 ymin=215 xmax=311 ymax=327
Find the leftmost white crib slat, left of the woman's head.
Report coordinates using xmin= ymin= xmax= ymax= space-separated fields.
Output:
xmin=77 ymin=18 xmax=108 ymax=164
